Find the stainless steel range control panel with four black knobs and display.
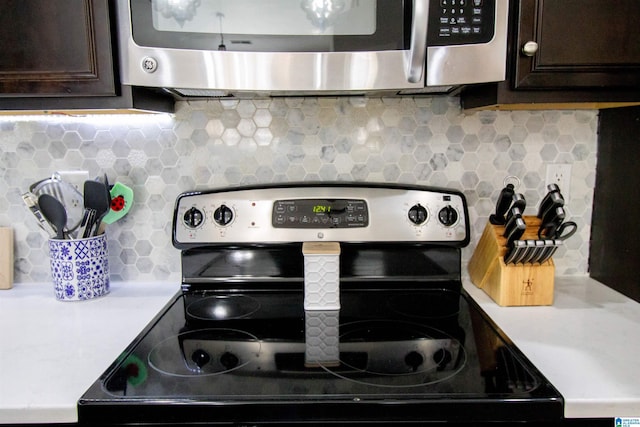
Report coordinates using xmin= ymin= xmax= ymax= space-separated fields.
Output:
xmin=173 ymin=184 xmax=469 ymax=248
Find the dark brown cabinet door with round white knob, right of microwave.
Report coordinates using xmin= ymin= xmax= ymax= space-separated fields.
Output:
xmin=512 ymin=0 xmax=640 ymax=89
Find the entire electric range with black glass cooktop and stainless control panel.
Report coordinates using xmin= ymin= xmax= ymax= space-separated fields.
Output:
xmin=78 ymin=183 xmax=563 ymax=425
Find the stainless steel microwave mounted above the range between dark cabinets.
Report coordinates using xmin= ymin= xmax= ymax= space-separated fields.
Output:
xmin=116 ymin=0 xmax=508 ymax=97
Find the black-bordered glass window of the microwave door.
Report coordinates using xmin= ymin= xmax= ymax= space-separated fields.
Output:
xmin=130 ymin=0 xmax=404 ymax=52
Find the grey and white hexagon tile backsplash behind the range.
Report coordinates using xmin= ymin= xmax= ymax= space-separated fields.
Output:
xmin=0 ymin=97 xmax=597 ymax=283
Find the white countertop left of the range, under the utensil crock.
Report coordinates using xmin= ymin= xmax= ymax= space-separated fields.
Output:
xmin=0 ymin=283 xmax=179 ymax=423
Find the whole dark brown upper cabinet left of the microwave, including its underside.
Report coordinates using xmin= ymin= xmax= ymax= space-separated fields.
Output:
xmin=0 ymin=0 xmax=174 ymax=113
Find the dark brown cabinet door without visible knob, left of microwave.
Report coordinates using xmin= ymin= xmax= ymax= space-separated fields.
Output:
xmin=0 ymin=0 xmax=116 ymax=97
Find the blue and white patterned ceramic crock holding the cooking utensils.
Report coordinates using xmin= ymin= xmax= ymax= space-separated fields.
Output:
xmin=49 ymin=234 xmax=109 ymax=301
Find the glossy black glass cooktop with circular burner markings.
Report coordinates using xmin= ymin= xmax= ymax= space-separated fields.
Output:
xmin=79 ymin=285 xmax=562 ymax=423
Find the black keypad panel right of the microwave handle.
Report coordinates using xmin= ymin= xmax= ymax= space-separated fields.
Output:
xmin=427 ymin=0 xmax=496 ymax=46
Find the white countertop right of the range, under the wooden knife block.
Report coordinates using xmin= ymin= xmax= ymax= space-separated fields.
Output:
xmin=464 ymin=277 xmax=640 ymax=418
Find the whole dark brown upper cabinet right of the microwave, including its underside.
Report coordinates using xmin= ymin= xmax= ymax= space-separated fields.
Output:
xmin=461 ymin=0 xmax=640 ymax=110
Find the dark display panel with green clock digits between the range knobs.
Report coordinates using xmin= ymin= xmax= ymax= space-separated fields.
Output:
xmin=271 ymin=199 xmax=369 ymax=228
